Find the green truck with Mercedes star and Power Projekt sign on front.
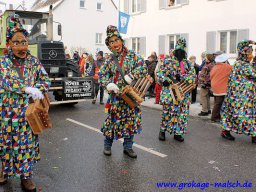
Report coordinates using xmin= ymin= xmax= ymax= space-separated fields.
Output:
xmin=0 ymin=6 xmax=94 ymax=105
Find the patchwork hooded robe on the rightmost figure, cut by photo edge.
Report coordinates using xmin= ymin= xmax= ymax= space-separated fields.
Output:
xmin=221 ymin=40 xmax=256 ymax=137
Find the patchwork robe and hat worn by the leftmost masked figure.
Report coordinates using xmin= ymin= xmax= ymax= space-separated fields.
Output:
xmin=0 ymin=14 xmax=50 ymax=179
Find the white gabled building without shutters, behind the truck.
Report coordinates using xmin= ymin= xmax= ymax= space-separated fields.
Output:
xmin=34 ymin=0 xmax=118 ymax=55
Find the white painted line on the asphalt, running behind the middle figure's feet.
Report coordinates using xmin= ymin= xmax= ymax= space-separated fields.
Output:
xmin=66 ymin=118 xmax=167 ymax=158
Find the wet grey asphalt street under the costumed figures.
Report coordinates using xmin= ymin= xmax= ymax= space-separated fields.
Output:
xmin=0 ymin=101 xmax=256 ymax=192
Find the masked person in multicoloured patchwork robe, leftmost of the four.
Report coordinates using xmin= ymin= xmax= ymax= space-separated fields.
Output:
xmin=0 ymin=15 xmax=50 ymax=191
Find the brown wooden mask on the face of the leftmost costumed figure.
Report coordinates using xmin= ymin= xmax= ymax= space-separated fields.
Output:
xmin=8 ymin=32 xmax=28 ymax=58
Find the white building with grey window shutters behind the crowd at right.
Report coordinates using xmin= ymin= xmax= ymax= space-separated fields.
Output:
xmin=120 ymin=0 xmax=256 ymax=60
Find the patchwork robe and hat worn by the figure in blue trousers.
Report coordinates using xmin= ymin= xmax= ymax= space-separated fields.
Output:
xmin=99 ymin=26 xmax=147 ymax=139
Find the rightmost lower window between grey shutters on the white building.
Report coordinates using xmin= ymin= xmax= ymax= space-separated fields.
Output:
xmin=219 ymin=31 xmax=237 ymax=54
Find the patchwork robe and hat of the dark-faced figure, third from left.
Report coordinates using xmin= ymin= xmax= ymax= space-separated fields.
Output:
xmin=158 ymin=38 xmax=196 ymax=135
